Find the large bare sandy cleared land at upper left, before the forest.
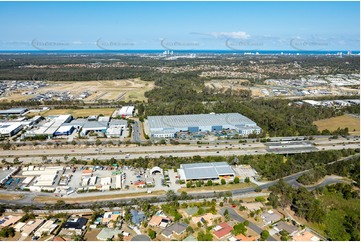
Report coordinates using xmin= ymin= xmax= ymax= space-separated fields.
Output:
xmin=0 ymin=78 xmax=154 ymax=102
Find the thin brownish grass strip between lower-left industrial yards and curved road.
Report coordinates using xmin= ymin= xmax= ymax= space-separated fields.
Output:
xmin=34 ymin=191 xmax=165 ymax=203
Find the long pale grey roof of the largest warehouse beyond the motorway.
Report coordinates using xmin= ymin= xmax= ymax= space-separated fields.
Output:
xmin=148 ymin=113 xmax=256 ymax=129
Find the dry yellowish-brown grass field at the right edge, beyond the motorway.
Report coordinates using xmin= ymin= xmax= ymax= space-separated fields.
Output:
xmin=313 ymin=115 xmax=360 ymax=135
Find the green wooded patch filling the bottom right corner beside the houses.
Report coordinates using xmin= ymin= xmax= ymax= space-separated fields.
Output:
xmin=268 ymin=180 xmax=360 ymax=241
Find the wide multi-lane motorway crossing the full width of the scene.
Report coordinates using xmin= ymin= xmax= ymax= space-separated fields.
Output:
xmin=0 ymin=143 xmax=360 ymax=163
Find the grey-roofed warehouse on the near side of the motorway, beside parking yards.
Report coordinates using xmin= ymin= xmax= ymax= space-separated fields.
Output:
xmin=178 ymin=162 xmax=235 ymax=181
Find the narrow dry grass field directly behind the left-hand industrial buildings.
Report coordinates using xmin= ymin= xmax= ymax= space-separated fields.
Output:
xmin=42 ymin=108 xmax=115 ymax=117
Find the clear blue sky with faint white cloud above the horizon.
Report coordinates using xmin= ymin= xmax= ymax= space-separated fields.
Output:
xmin=0 ymin=2 xmax=360 ymax=51
